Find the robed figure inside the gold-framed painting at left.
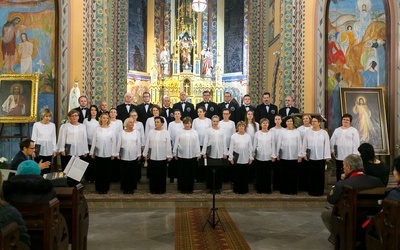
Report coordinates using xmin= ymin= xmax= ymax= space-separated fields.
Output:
xmin=1 ymin=83 xmax=26 ymax=116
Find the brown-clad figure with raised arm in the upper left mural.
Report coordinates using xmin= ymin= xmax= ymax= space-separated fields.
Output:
xmin=1 ymin=17 xmax=21 ymax=73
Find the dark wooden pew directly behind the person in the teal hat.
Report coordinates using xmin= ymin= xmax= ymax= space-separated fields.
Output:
xmin=11 ymin=198 xmax=69 ymax=250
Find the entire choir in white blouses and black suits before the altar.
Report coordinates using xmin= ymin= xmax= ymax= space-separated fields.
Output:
xmin=26 ymin=91 xmax=360 ymax=196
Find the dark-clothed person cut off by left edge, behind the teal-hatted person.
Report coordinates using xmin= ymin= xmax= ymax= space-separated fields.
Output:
xmin=0 ymin=174 xmax=31 ymax=246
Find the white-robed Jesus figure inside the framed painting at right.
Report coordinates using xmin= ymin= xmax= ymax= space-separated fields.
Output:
xmin=353 ymin=97 xmax=379 ymax=144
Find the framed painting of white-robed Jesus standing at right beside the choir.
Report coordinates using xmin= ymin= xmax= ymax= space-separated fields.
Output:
xmin=340 ymin=87 xmax=390 ymax=155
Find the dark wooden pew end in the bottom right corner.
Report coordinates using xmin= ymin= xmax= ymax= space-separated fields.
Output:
xmin=365 ymin=198 xmax=400 ymax=250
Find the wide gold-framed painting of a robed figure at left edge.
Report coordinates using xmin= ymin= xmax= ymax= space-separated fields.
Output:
xmin=0 ymin=74 xmax=39 ymax=123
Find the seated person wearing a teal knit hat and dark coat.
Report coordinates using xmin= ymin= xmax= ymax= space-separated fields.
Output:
xmin=3 ymin=160 xmax=56 ymax=203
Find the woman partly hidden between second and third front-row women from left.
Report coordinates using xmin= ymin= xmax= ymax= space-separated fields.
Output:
xmin=83 ymin=105 xmax=100 ymax=181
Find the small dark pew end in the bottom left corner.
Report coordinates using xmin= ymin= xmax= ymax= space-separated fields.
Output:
xmin=0 ymin=222 xmax=29 ymax=250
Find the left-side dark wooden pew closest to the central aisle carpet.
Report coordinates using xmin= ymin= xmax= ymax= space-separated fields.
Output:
xmin=54 ymin=183 xmax=89 ymax=250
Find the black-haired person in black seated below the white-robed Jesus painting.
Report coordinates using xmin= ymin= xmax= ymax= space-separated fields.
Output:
xmin=358 ymin=142 xmax=389 ymax=187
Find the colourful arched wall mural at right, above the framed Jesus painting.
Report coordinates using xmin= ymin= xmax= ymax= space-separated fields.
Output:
xmin=326 ymin=0 xmax=387 ymax=128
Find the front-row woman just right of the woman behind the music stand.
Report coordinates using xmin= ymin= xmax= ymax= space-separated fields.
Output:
xmin=229 ymin=121 xmax=253 ymax=194
